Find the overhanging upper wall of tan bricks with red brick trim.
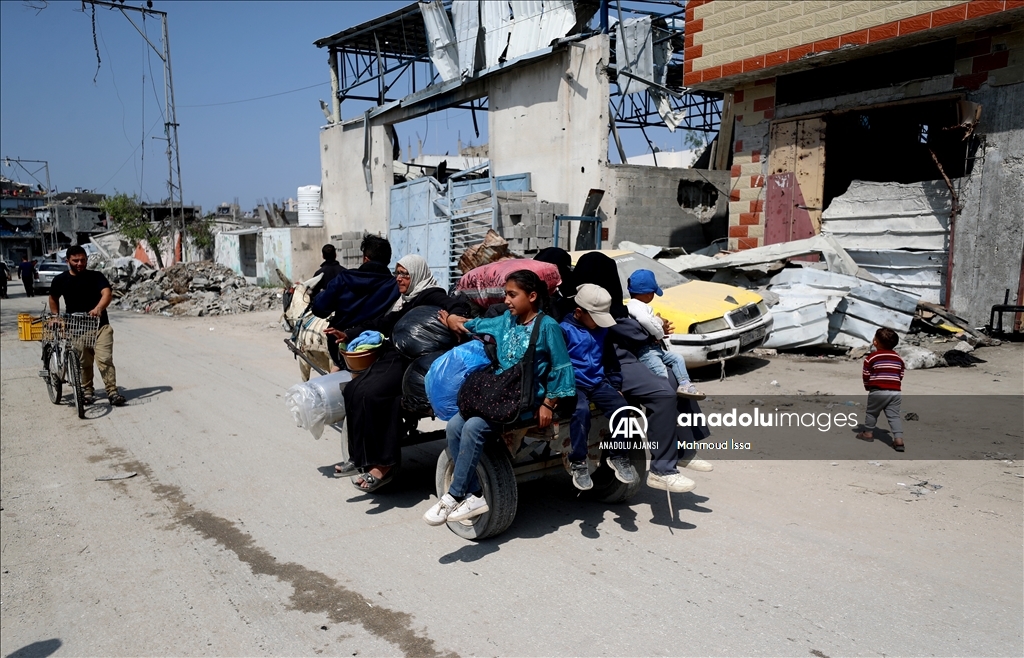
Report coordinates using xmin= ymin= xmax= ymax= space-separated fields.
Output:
xmin=684 ymin=0 xmax=1024 ymax=88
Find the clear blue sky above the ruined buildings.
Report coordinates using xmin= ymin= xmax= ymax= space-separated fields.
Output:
xmin=0 ymin=0 xmax=696 ymax=211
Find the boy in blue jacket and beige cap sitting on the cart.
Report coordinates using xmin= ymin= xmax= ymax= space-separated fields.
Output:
xmin=561 ymin=283 xmax=638 ymax=490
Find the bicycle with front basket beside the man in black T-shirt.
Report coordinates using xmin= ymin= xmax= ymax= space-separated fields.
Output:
xmin=39 ymin=313 xmax=99 ymax=419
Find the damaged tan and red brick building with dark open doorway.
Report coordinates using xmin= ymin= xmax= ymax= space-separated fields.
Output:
xmin=684 ymin=0 xmax=1024 ymax=326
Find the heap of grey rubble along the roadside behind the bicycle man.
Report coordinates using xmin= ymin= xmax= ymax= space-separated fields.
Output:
xmin=103 ymin=258 xmax=282 ymax=316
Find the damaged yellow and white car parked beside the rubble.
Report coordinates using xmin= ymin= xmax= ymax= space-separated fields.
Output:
xmin=571 ymin=250 xmax=774 ymax=367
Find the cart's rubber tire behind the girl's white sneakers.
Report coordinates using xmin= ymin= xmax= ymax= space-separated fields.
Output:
xmin=434 ymin=441 xmax=519 ymax=541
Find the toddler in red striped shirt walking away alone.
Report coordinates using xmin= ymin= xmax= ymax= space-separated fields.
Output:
xmin=857 ymin=327 xmax=906 ymax=452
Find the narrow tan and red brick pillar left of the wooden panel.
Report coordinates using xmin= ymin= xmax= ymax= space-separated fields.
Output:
xmin=729 ymin=78 xmax=775 ymax=250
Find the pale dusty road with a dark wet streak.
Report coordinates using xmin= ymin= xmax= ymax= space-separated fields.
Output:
xmin=0 ymin=286 xmax=1024 ymax=656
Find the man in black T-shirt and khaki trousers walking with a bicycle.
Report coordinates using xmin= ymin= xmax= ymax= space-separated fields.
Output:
xmin=50 ymin=246 xmax=126 ymax=406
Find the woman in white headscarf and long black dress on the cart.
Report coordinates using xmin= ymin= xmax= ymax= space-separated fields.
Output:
xmin=335 ymin=254 xmax=465 ymax=491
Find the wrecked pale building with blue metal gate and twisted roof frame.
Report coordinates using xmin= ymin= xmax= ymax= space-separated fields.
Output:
xmin=315 ymin=0 xmax=730 ymax=284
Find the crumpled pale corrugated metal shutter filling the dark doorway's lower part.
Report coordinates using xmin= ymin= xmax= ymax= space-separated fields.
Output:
xmin=821 ymin=180 xmax=951 ymax=303
